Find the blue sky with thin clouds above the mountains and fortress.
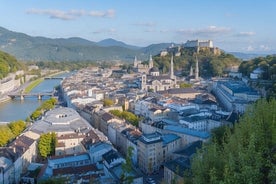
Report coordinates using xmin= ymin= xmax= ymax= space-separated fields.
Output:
xmin=0 ymin=0 xmax=276 ymax=53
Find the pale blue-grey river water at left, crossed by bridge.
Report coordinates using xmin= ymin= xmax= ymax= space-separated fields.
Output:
xmin=0 ymin=75 xmax=68 ymax=122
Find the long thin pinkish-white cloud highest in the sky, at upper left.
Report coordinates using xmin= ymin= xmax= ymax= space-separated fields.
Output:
xmin=27 ymin=9 xmax=115 ymax=20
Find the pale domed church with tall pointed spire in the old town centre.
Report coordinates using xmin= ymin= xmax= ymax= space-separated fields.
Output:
xmin=140 ymin=56 xmax=179 ymax=92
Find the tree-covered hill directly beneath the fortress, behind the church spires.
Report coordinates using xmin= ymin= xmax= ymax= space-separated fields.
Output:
xmin=153 ymin=48 xmax=241 ymax=77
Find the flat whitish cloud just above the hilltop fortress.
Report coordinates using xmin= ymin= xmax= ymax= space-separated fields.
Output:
xmin=177 ymin=26 xmax=231 ymax=36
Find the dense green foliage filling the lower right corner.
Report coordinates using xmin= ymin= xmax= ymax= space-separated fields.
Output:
xmin=192 ymin=99 xmax=276 ymax=184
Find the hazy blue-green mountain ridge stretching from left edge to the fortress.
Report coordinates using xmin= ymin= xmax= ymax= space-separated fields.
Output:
xmin=0 ymin=27 xmax=170 ymax=61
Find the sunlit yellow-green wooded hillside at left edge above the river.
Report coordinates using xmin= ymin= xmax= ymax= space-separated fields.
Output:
xmin=0 ymin=51 xmax=24 ymax=79
